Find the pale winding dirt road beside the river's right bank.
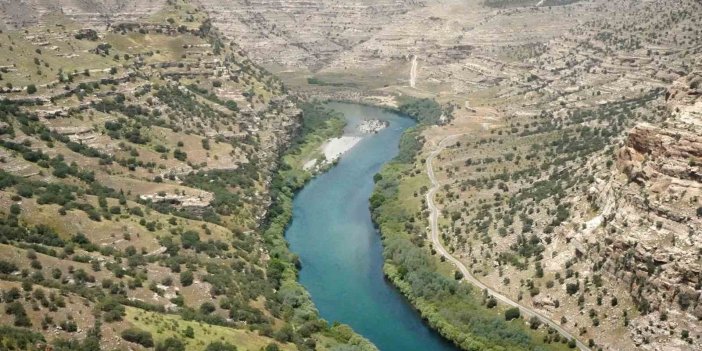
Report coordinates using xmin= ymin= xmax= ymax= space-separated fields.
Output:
xmin=426 ymin=134 xmax=591 ymax=351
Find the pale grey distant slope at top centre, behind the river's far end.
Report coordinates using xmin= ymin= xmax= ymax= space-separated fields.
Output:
xmin=191 ymin=0 xmax=424 ymax=70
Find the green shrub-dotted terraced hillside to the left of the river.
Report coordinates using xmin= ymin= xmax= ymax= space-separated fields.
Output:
xmin=0 ymin=1 xmax=380 ymax=350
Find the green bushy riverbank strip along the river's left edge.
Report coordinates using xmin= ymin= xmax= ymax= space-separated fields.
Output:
xmin=263 ymin=103 xmax=377 ymax=351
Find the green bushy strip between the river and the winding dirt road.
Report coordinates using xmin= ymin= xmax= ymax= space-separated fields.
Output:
xmin=371 ymin=98 xmax=569 ymax=350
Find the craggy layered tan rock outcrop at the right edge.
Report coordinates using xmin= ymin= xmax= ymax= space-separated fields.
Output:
xmin=601 ymin=73 xmax=702 ymax=345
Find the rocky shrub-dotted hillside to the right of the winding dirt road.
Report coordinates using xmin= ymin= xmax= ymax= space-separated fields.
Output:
xmin=418 ymin=1 xmax=702 ymax=350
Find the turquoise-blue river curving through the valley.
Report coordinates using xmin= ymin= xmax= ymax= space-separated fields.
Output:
xmin=286 ymin=103 xmax=457 ymax=351
